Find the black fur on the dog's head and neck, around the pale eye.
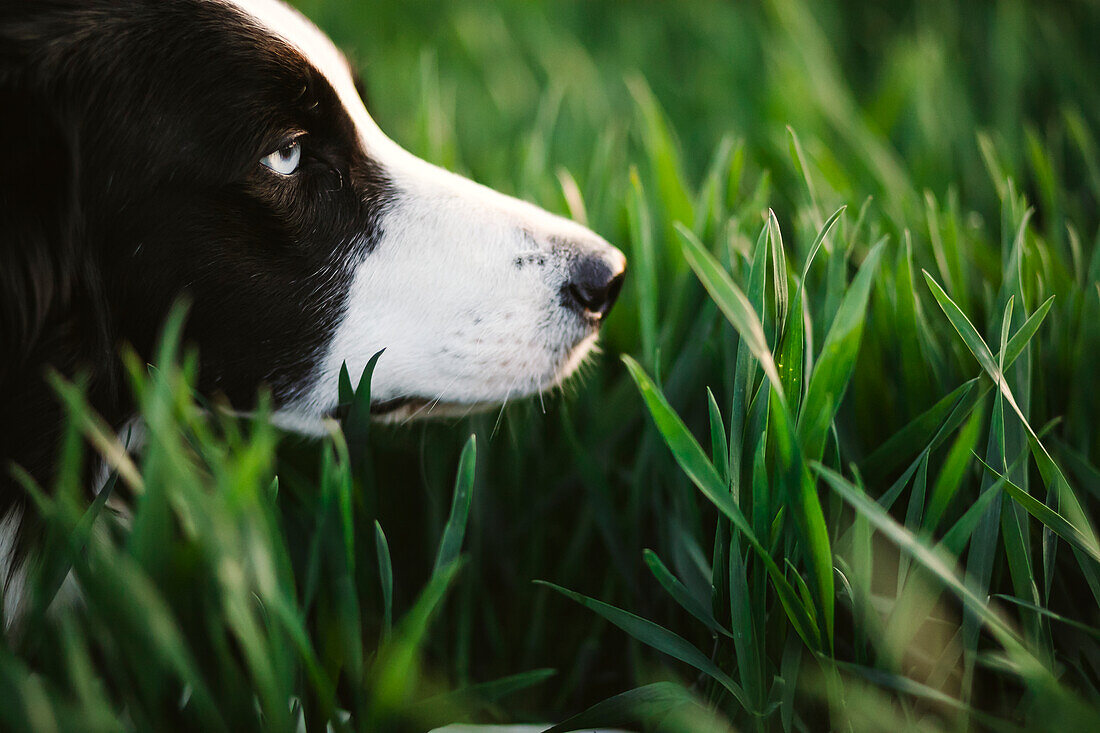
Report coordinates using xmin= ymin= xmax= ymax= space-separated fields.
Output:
xmin=0 ymin=0 xmax=393 ymax=581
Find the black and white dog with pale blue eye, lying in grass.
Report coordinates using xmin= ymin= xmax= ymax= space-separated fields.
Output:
xmin=0 ymin=0 xmax=626 ymax=620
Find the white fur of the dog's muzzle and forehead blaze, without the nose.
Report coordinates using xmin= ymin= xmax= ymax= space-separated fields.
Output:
xmin=225 ymin=0 xmax=626 ymax=431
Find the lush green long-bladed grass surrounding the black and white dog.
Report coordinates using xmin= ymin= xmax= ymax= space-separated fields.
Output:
xmin=0 ymin=0 xmax=1100 ymax=733
